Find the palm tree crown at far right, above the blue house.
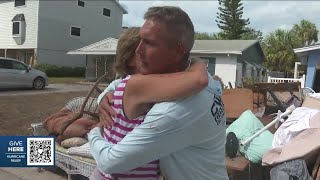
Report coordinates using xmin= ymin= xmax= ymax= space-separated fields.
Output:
xmin=291 ymin=19 xmax=319 ymax=47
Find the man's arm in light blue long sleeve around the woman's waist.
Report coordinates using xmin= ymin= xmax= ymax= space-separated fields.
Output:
xmin=89 ymin=103 xmax=212 ymax=173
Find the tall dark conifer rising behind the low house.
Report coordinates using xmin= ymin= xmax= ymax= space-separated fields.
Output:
xmin=216 ymin=0 xmax=250 ymax=39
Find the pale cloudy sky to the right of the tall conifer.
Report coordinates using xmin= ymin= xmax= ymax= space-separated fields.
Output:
xmin=244 ymin=1 xmax=320 ymax=34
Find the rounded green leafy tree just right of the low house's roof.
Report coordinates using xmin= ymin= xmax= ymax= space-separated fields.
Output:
xmin=262 ymin=29 xmax=297 ymax=73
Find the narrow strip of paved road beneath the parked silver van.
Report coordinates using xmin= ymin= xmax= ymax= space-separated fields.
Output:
xmin=0 ymin=84 xmax=92 ymax=96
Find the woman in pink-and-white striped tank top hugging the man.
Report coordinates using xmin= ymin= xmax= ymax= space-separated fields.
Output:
xmin=90 ymin=28 xmax=208 ymax=180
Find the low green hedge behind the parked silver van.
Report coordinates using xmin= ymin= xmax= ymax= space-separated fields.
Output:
xmin=33 ymin=64 xmax=86 ymax=77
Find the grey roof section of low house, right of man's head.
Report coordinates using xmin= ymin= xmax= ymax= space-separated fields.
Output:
xmin=191 ymin=40 xmax=259 ymax=54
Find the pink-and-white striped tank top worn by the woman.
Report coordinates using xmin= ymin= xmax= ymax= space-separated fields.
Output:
xmin=101 ymin=76 xmax=160 ymax=180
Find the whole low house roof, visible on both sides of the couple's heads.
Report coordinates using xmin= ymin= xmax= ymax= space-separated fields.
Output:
xmin=68 ymin=38 xmax=259 ymax=55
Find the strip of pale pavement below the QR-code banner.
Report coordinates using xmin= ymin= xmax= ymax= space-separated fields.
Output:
xmin=0 ymin=168 xmax=67 ymax=180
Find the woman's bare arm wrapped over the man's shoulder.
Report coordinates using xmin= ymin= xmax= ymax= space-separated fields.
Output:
xmin=124 ymin=61 xmax=208 ymax=118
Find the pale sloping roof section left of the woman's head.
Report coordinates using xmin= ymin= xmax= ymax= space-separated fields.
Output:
xmin=67 ymin=37 xmax=118 ymax=55
